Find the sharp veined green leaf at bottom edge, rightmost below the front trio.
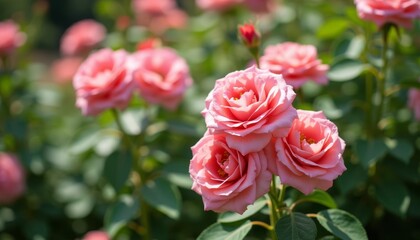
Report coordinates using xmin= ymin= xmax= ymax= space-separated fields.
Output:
xmin=317 ymin=209 xmax=368 ymax=240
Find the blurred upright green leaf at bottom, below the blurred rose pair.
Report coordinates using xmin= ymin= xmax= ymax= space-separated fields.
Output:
xmin=105 ymin=195 xmax=140 ymax=239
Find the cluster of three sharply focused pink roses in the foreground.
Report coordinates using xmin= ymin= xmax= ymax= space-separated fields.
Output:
xmin=189 ymin=66 xmax=346 ymax=213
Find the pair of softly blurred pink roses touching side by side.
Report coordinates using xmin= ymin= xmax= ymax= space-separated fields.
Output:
xmin=73 ymin=45 xmax=192 ymax=115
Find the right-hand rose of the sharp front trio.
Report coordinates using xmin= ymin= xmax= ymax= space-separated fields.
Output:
xmin=269 ymin=110 xmax=346 ymax=194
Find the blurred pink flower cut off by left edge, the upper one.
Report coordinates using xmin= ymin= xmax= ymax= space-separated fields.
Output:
xmin=0 ymin=20 xmax=26 ymax=55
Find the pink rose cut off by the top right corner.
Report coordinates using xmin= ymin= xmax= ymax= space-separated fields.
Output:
xmin=354 ymin=0 xmax=420 ymax=28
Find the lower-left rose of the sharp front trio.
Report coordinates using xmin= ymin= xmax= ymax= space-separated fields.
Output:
xmin=190 ymin=132 xmax=275 ymax=214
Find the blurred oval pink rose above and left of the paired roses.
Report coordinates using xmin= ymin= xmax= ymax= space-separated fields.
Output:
xmin=60 ymin=19 xmax=106 ymax=55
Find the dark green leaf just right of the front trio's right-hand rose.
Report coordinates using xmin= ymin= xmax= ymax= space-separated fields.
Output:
xmin=355 ymin=139 xmax=388 ymax=168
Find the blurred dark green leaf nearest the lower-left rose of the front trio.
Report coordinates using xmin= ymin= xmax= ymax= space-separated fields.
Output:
xmin=141 ymin=178 xmax=181 ymax=219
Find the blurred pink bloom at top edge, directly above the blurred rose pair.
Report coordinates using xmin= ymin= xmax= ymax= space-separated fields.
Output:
xmin=133 ymin=0 xmax=188 ymax=34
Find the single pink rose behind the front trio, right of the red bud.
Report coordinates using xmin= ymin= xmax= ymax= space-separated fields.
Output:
xmin=260 ymin=42 xmax=328 ymax=89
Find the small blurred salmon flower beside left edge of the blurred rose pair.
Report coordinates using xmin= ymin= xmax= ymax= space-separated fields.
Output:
xmin=51 ymin=57 xmax=83 ymax=83
